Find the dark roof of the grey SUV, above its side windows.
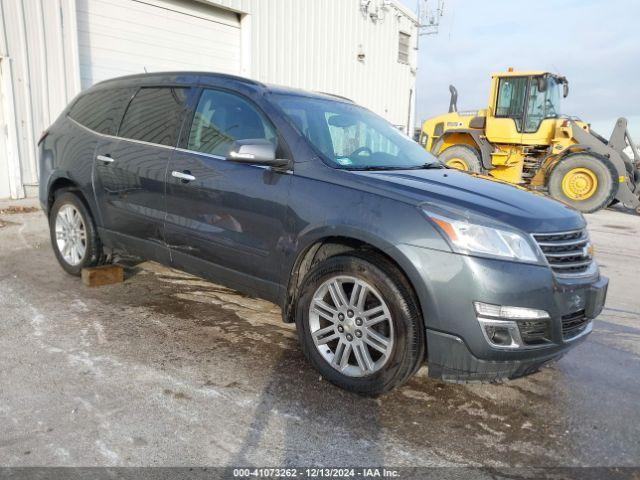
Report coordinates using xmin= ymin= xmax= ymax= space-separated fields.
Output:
xmin=92 ymin=71 xmax=353 ymax=103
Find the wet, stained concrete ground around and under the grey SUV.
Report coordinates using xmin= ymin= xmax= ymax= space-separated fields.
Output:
xmin=0 ymin=198 xmax=640 ymax=469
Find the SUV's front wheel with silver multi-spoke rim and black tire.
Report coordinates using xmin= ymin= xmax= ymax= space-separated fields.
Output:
xmin=296 ymin=253 xmax=425 ymax=396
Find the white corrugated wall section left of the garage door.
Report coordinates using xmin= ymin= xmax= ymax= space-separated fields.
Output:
xmin=0 ymin=0 xmax=80 ymax=198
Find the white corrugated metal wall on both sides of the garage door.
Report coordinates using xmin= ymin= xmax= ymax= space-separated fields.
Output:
xmin=0 ymin=0 xmax=417 ymax=198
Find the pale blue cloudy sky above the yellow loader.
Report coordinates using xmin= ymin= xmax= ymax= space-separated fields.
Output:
xmin=400 ymin=0 xmax=640 ymax=139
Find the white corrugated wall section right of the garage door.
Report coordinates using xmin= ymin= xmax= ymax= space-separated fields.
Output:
xmin=208 ymin=0 xmax=417 ymax=126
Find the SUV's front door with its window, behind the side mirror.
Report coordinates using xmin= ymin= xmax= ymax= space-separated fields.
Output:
xmin=166 ymin=89 xmax=291 ymax=298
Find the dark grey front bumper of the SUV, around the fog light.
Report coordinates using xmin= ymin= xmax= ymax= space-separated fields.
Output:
xmin=403 ymin=245 xmax=608 ymax=382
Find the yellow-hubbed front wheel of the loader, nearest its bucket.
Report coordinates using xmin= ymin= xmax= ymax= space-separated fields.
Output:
xmin=547 ymin=153 xmax=618 ymax=213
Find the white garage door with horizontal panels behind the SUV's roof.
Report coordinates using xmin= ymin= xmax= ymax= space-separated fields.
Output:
xmin=76 ymin=0 xmax=240 ymax=88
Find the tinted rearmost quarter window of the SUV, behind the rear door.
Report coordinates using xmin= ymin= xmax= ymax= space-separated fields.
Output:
xmin=69 ymin=88 xmax=135 ymax=135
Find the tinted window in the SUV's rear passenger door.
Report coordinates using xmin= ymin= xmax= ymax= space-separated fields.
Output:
xmin=118 ymin=87 xmax=187 ymax=147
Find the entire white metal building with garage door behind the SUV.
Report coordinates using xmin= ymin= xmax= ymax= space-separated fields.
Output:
xmin=0 ymin=0 xmax=417 ymax=198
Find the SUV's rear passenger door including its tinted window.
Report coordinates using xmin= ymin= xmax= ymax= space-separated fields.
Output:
xmin=94 ymin=87 xmax=189 ymax=256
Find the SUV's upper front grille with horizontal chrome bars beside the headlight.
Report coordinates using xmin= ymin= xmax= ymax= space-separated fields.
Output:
xmin=533 ymin=229 xmax=593 ymax=275
